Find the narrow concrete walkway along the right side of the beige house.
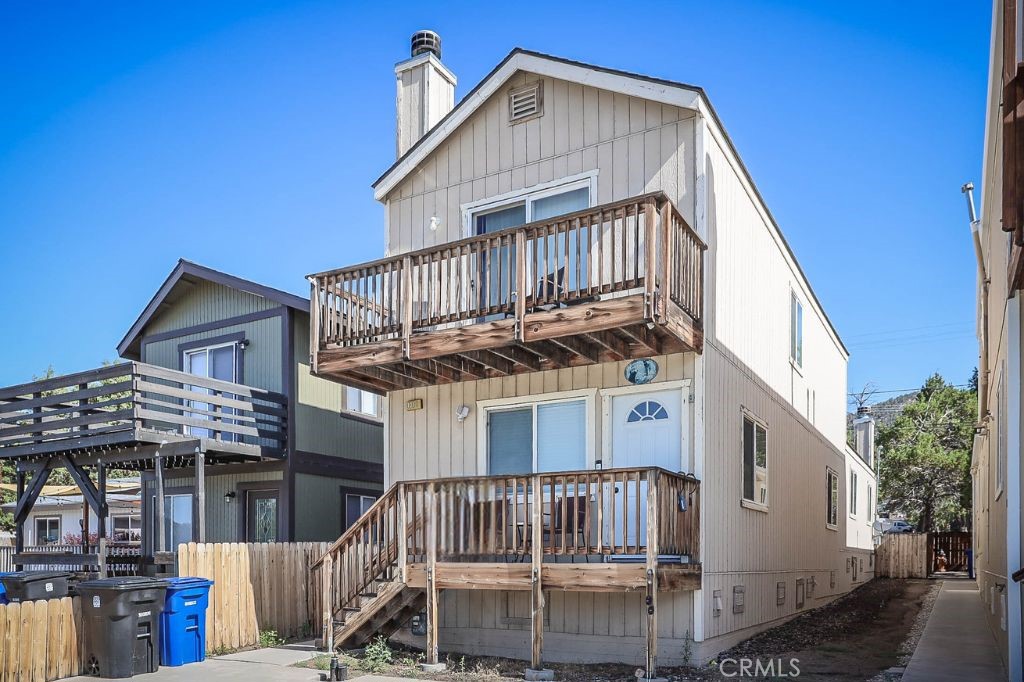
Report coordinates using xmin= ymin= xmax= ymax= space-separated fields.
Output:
xmin=903 ymin=579 xmax=1007 ymax=682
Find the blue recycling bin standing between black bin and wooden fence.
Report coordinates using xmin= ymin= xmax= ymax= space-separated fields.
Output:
xmin=160 ymin=578 xmax=213 ymax=666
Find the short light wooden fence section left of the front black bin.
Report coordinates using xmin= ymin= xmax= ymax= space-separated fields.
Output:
xmin=0 ymin=597 xmax=82 ymax=682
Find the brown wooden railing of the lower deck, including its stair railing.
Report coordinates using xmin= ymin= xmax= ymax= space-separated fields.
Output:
xmin=313 ymin=468 xmax=700 ymax=630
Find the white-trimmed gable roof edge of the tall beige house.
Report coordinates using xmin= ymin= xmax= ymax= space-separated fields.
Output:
xmin=372 ymin=47 xmax=850 ymax=357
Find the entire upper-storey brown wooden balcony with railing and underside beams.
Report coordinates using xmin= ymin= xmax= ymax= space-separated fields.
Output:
xmin=310 ymin=193 xmax=707 ymax=392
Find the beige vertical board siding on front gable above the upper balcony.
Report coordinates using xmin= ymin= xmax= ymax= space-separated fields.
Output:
xmin=385 ymin=73 xmax=693 ymax=255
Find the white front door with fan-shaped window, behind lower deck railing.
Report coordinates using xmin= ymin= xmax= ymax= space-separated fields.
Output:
xmin=604 ymin=388 xmax=689 ymax=547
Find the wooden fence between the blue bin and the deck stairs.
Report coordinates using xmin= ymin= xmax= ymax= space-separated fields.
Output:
xmin=178 ymin=543 xmax=330 ymax=652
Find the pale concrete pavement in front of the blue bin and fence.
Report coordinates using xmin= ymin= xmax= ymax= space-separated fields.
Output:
xmin=71 ymin=642 xmax=319 ymax=682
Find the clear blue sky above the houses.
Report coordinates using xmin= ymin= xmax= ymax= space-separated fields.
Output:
xmin=0 ymin=1 xmax=991 ymax=397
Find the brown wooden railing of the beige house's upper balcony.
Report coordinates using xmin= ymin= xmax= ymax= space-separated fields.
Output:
xmin=311 ymin=193 xmax=706 ymax=348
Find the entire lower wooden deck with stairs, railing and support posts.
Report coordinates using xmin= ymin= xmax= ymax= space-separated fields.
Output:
xmin=312 ymin=468 xmax=700 ymax=671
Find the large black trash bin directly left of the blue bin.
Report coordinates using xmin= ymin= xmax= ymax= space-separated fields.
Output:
xmin=78 ymin=578 xmax=167 ymax=677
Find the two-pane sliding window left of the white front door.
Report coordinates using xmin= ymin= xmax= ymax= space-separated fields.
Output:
xmin=486 ymin=398 xmax=587 ymax=475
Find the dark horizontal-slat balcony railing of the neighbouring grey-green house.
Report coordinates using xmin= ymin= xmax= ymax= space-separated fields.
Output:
xmin=0 ymin=363 xmax=288 ymax=458
